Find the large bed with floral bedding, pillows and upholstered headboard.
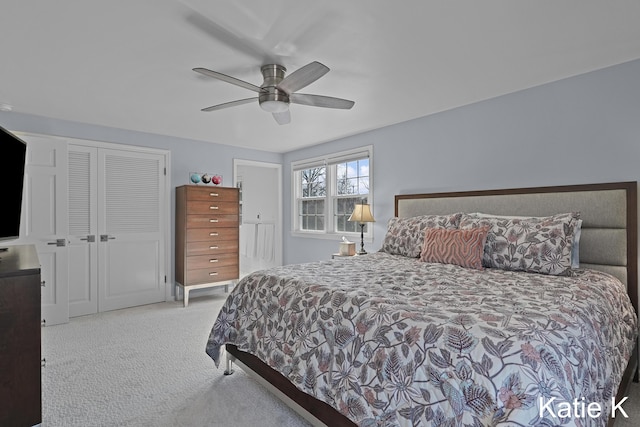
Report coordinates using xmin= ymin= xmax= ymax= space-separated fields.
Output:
xmin=206 ymin=182 xmax=638 ymax=426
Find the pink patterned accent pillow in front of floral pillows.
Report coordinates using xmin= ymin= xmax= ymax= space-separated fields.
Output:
xmin=420 ymin=227 xmax=489 ymax=270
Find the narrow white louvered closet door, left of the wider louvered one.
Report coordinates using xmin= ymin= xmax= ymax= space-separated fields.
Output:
xmin=68 ymin=144 xmax=98 ymax=317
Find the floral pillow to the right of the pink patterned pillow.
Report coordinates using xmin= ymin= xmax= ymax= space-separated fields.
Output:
xmin=460 ymin=212 xmax=580 ymax=276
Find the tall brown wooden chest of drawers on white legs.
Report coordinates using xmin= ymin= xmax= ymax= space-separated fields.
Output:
xmin=176 ymin=185 xmax=240 ymax=307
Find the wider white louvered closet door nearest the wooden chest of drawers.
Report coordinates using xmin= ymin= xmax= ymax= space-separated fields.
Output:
xmin=97 ymin=149 xmax=166 ymax=311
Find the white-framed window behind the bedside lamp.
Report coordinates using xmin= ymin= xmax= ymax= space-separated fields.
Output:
xmin=292 ymin=146 xmax=373 ymax=238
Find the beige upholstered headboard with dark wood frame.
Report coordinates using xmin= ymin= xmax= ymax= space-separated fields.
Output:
xmin=395 ymin=182 xmax=638 ymax=311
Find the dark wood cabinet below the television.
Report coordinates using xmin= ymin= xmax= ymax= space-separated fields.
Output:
xmin=0 ymin=244 xmax=42 ymax=427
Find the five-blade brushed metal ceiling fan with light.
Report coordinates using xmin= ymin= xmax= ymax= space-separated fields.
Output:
xmin=193 ymin=61 xmax=355 ymax=125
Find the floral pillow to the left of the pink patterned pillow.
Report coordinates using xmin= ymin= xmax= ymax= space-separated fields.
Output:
xmin=380 ymin=213 xmax=462 ymax=258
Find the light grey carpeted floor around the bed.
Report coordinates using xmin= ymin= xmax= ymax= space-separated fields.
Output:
xmin=42 ymin=293 xmax=640 ymax=427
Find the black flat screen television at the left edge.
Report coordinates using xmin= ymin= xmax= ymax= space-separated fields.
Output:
xmin=0 ymin=127 xmax=27 ymax=241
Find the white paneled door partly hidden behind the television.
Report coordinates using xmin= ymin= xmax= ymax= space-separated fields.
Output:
xmin=19 ymin=135 xmax=69 ymax=325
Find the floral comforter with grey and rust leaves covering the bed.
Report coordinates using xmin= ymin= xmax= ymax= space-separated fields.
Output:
xmin=206 ymin=252 xmax=638 ymax=426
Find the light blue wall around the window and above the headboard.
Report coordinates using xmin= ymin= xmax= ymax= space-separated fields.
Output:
xmin=284 ymin=61 xmax=640 ymax=263
